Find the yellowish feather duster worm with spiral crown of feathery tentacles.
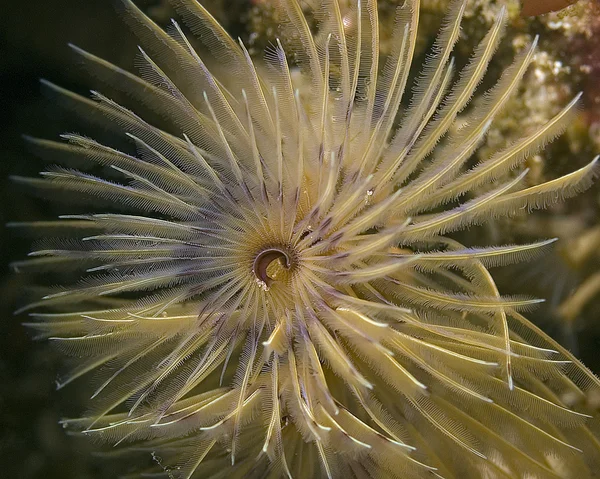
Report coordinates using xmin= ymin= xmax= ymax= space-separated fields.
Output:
xmin=11 ymin=0 xmax=600 ymax=478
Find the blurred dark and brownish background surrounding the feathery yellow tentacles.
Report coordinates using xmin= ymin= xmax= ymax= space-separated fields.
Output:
xmin=0 ymin=0 xmax=600 ymax=479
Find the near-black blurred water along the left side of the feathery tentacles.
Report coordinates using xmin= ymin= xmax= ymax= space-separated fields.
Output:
xmin=0 ymin=0 xmax=600 ymax=479
